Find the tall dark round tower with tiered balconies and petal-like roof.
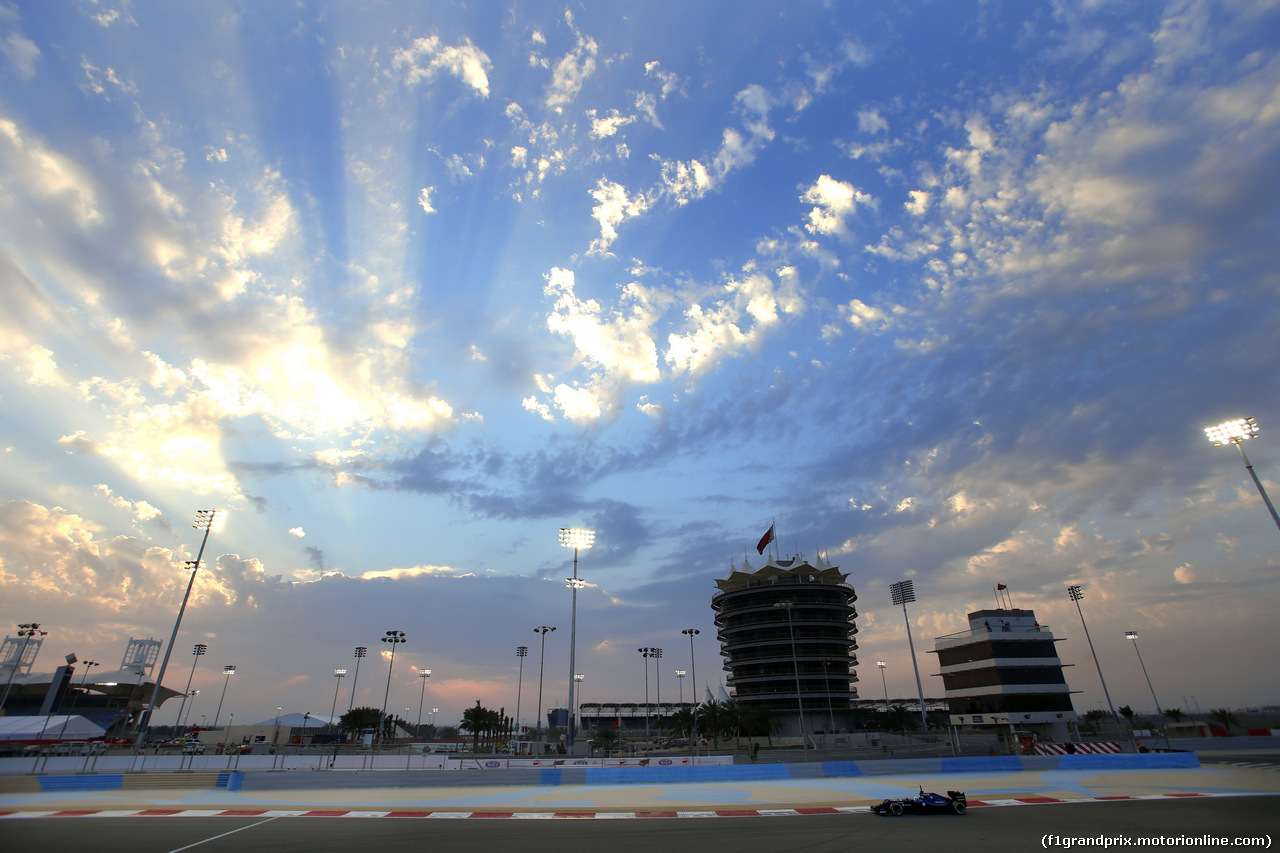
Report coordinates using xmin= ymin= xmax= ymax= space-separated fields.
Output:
xmin=712 ymin=557 xmax=858 ymax=735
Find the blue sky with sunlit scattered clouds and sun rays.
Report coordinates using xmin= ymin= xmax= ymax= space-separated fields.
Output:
xmin=0 ymin=0 xmax=1280 ymax=725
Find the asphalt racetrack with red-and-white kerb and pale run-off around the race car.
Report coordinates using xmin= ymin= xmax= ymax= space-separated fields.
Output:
xmin=0 ymin=761 xmax=1280 ymax=853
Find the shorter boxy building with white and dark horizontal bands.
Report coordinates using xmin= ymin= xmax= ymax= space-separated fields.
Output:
xmin=933 ymin=608 xmax=1079 ymax=740
